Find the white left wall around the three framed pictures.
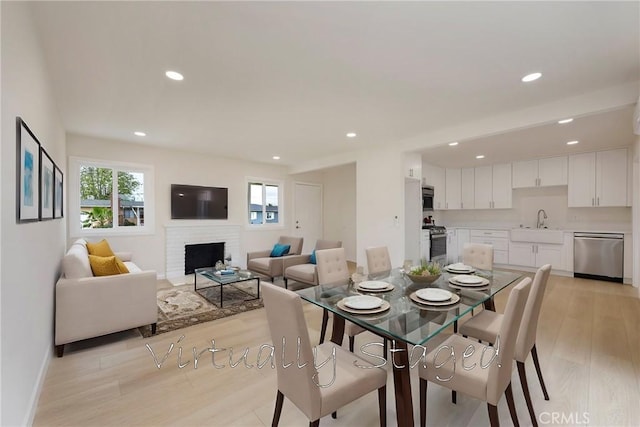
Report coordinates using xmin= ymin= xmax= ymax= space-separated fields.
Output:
xmin=0 ymin=2 xmax=66 ymax=426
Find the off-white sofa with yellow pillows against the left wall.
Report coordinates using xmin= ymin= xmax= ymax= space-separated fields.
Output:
xmin=55 ymin=239 xmax=158 ymax=357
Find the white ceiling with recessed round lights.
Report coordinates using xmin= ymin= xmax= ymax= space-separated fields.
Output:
xmin=26 ymin=1 xmax=640 ymax=166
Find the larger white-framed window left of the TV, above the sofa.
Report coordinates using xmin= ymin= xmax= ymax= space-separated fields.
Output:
xmin=69 ymin=158 xmax=153 ymax=236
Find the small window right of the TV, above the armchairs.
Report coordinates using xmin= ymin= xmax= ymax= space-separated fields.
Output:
xmin=248 ymin=180 xmax=282 ymax=225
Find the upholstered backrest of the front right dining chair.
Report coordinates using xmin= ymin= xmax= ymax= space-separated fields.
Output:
xmin=488 ymin=277 xmax=531 ymax=405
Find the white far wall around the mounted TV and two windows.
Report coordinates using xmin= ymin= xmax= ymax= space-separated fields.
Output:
xmin=67 ymin=134 xmax=330 ymax=275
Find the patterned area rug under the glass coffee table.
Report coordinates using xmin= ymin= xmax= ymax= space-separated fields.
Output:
xmin=138 ymin=283 xmax=263 ymax=338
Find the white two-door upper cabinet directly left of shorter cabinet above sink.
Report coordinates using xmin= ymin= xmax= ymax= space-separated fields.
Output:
xmin=474 ymin=163 xmax=511 ymax=209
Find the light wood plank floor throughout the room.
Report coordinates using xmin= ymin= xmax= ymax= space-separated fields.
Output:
xmin=34 ymin=276 xmax=640 ymax=426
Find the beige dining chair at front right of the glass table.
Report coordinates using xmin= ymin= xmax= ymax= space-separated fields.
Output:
xmin=418 ymin=277 xmax=531 ymax=427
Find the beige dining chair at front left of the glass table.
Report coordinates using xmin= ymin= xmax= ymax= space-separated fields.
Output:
xmin=262 ymin=283 xmax=387 ymax=427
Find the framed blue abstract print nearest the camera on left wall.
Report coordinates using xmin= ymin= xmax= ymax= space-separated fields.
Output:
xmin=16 ymin=117 xmax=40 ymax=223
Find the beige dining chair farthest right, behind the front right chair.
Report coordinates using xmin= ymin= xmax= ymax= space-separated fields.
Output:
xmin=459 ymin=264 xmax=551 ymax=426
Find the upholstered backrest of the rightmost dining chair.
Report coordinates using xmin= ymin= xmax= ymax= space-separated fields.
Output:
xmin=515 ymin=264 xmax=551 ymax=362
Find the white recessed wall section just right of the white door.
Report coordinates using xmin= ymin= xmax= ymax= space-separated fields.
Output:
xmin=323 ymin=163 xmax=358 ymax=262
